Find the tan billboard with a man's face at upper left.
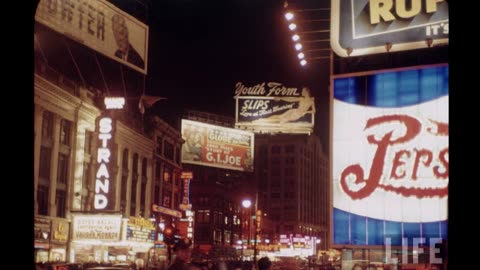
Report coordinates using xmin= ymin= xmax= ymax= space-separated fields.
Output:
xmin=35 ymin=0 xmax=148 ymax=74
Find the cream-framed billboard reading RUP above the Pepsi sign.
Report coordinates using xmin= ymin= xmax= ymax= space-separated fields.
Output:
xmin=330 ymin=0 xmax=449 ymax=57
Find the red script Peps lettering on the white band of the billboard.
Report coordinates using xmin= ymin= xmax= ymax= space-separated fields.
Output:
xmin=340 ymin=115 xmax=449 ymax=200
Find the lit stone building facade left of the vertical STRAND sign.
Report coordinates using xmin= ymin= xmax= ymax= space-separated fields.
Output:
xmin=34 ymin=62 xmax=100 ymax=261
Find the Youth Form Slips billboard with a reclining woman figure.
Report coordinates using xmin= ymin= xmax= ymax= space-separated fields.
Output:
xmin=235 ymin=82 xmax=315 ymax=134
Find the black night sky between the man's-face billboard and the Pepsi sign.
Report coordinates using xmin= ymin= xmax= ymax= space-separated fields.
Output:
xmin=146 ymin=0 xmax=329 ymax=148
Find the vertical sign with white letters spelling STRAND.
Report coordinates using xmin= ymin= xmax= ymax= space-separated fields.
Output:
xmin=93 ymin=116 xmax=115 ymax=210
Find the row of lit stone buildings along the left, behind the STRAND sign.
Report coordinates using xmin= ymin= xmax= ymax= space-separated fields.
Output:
xmin=34 ymin=59 xmax=183 ymax=262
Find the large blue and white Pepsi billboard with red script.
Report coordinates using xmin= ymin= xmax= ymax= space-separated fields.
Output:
xmin=332 ymin=65 xmax=449 ymax=246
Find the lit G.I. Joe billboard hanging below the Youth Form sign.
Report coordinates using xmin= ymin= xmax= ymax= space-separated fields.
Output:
xmin=182 ymin=119 xmax=254 ymax=172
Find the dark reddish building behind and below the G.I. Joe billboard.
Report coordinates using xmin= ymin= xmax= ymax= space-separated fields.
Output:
xmin=183 ymin=110 xmax=254 ymax=258
